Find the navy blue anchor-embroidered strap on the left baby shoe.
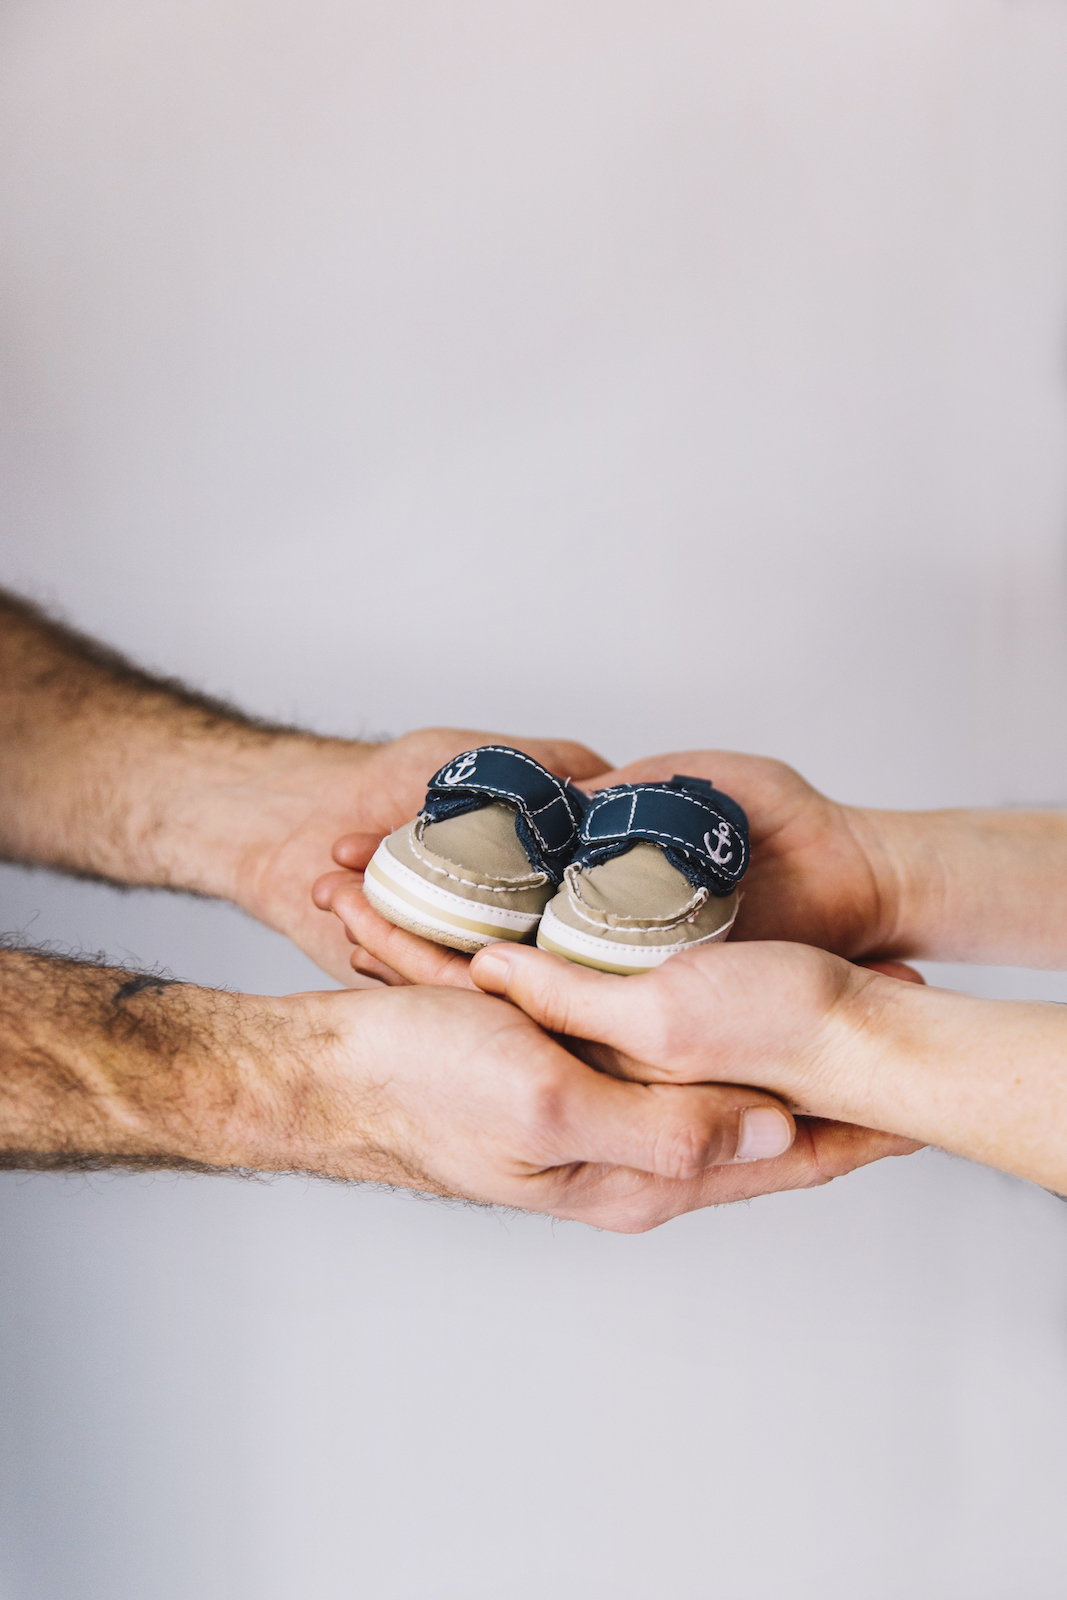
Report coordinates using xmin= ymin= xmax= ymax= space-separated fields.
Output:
xmin=422 ymin=744 xmax=585 ymax=883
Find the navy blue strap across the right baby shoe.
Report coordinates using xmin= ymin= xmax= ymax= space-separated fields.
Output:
xmin=574 ymin=778 xmax=749 ymax=894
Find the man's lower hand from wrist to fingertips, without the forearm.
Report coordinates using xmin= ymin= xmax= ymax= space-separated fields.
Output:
xmin=280 ymin=972 xmax=921 ymax=1232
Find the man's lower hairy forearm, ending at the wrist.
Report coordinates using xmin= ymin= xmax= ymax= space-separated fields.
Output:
xmin=0 ymin=949 xmax=303 ymax=1170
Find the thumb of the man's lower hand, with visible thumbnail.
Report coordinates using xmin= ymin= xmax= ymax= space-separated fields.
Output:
xmin=558 ymin=1072 xmax=795 ymax=1179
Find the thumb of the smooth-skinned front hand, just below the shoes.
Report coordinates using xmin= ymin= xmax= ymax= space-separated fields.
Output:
xmin=470 ymin=944 xmax=651 ymax=1051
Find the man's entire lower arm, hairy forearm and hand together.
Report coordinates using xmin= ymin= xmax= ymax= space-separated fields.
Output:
xmin=0 ymin=950 xmax=885 ymax=1232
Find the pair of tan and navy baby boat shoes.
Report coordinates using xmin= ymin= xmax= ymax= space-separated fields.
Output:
xmin=363 ymin=744 xmax=749 ymax=974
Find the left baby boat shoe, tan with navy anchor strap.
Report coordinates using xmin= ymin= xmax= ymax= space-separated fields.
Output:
xmin=363 ymin=744 xmax=587 ymax=950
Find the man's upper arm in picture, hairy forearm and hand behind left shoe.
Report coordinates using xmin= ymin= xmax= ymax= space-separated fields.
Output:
xmin=0 ymin=590 xmax=606 ymax=982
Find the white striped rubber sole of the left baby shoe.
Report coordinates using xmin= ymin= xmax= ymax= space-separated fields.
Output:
xmin=363 ymin=840 xmax=541 ymax=952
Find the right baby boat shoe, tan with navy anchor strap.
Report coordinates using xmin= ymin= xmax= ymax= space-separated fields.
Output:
xmin=537 ymin=778 xmax=749 ymax=974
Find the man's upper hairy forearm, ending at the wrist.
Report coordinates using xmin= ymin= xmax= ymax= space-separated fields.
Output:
xmin=0 ymin=590 xmax=367 ymax=898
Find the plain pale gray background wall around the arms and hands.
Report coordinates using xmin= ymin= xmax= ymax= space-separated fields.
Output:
xmin=0 ymin=0 xmax=1067 ymax=1600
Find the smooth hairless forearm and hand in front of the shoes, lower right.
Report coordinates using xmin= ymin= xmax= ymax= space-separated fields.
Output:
xmin=470 ymin=941 xmax=1067 ymax=1192
